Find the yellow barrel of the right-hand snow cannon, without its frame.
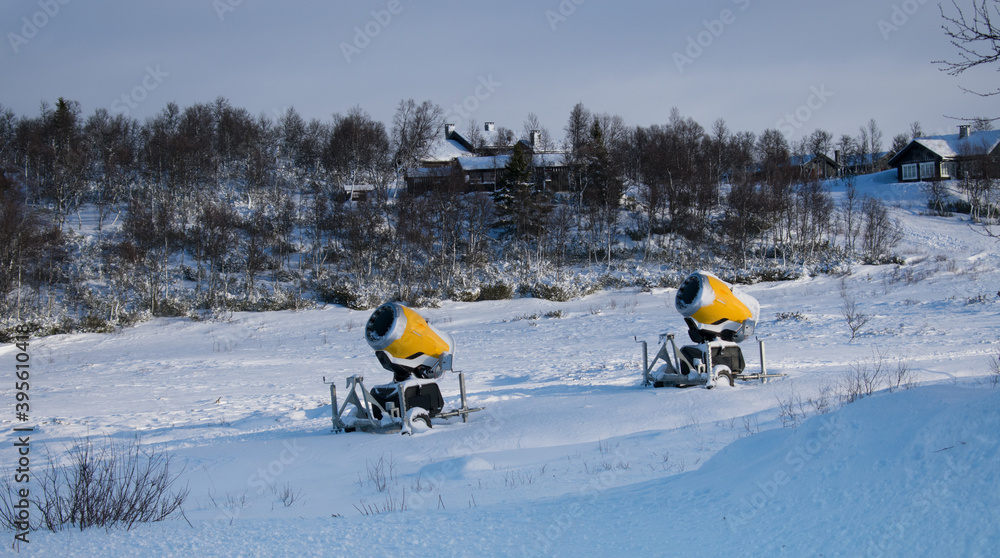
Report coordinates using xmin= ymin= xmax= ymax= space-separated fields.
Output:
xmin=674 ymin=271 xmax=760 ymax=343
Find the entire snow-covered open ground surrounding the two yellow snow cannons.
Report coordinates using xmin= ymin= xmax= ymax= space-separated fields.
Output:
xmin=0 ymin=173 xmax=1000 ymax=556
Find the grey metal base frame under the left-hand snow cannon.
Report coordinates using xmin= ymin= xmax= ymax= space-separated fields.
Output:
xmin=323 ymin=372 xmax=483 ymax=434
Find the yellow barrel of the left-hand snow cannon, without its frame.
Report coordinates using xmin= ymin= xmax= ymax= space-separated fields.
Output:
xmin=365 ymin=302 xmax=455 ymax=382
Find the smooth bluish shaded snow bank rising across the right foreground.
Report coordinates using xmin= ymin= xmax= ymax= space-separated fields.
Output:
xmin=27 ymin=384 xmax=1000 ymax=556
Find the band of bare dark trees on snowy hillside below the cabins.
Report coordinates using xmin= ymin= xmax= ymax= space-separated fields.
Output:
xmin=0 ymin=98 xmax=917 ymax=336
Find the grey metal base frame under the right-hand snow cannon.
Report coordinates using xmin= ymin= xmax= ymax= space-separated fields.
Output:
xmin=636 ymin=333 xmax=785 ymax=389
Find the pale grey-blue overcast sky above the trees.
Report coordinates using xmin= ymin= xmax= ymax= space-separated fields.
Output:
xmin=0 ymin=0 xmax=1000 ymax=147
